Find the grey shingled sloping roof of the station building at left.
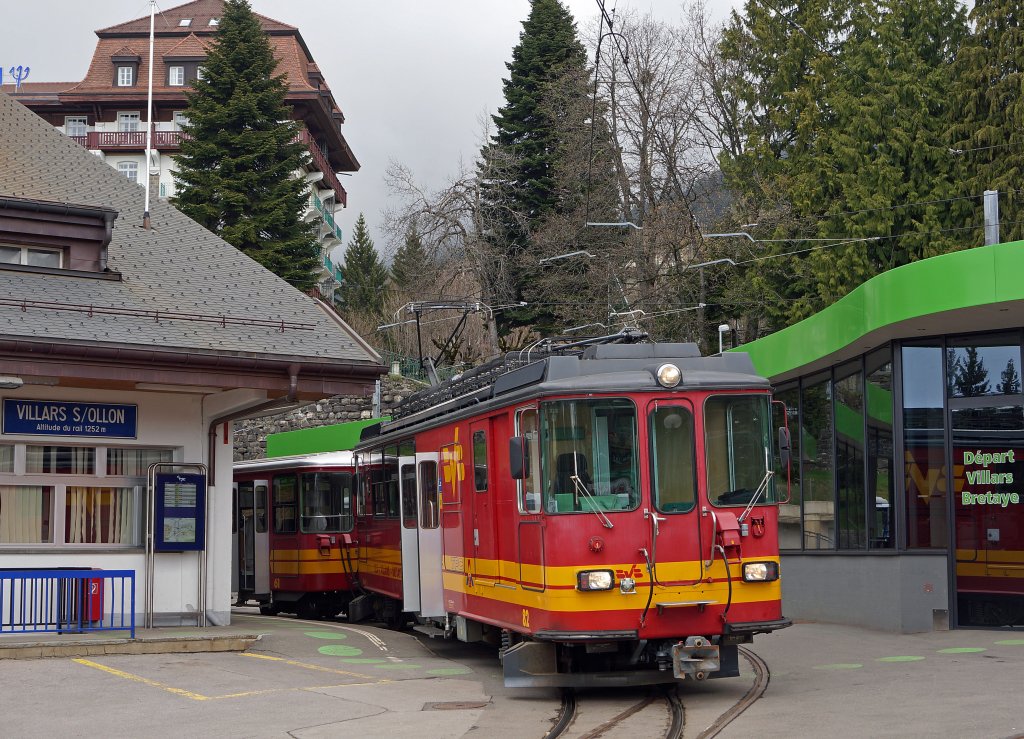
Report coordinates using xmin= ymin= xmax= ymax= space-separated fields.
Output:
xmin=0 ymin=92 xmax=380 ymax=364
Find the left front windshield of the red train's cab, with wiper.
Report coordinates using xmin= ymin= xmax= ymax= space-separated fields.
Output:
xmin=540 ymin=398 xmax=640 ymax=513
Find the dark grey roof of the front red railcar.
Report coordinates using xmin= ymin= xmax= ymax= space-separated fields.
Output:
xmin=362 ymin=343 xmax=770 ymax=440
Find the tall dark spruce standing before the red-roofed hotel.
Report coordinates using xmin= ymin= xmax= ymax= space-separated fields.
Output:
xmin=173 ymin=0 xmax=318 ymax=291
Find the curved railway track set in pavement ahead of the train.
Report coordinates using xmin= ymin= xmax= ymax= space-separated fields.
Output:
xmin=545 ymin=647 xmax=771 ymax=739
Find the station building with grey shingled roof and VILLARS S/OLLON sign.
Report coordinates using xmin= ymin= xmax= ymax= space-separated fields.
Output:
xmin=0 ymin=93 xmax=384 ymax=625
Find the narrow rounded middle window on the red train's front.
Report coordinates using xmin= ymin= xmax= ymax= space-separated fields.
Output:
xmin=650 ymin=405 xmax=697 ymax=513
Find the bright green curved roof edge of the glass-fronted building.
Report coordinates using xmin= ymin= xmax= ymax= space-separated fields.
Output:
xmin=734 ymin=242 xmax=1024 ymax=383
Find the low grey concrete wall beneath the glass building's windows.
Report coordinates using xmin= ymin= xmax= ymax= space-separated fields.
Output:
xmin=782 ymin=552 xmax=949 ymax=634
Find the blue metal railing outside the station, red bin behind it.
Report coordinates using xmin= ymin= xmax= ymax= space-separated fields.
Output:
xmin=0 ymin=569 xmax=135 ymax=639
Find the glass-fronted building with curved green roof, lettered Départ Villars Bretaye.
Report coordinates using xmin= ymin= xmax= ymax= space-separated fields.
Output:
xmin=736 ymin=243 xmax=1024 ymax=633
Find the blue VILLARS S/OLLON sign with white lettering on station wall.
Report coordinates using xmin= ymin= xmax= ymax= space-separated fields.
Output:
xmin=3 ymin=398 xmax=138 ymax=439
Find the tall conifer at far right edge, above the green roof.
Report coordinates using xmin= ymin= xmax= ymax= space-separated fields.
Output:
xmin=950 ymin=0 xmax=1024 ymax=245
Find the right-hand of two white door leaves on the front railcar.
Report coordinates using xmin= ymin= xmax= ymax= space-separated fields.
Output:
xmin=416 ymin=452 xmax=446 ymax=616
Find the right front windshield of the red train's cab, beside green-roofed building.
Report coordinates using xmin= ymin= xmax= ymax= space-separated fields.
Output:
xmin=705 ymin=395 xmax=775 ymax=506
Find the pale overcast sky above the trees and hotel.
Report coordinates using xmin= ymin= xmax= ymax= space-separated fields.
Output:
xmin=0 ymin=0 xmax=736 ymax=261
